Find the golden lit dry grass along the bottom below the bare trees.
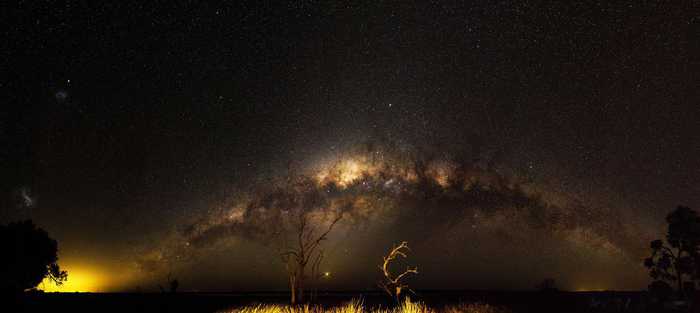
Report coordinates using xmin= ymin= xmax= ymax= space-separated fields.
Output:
xmin=219 ymin=299 xmax=511 ymax=313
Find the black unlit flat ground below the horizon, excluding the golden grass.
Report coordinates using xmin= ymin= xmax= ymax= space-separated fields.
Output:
xmin=0 ymin=291 xmax=667 ymax=313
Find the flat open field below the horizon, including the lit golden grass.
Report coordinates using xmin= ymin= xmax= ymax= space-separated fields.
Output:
xmin=9 ymin=291 xmax=659 ymax=313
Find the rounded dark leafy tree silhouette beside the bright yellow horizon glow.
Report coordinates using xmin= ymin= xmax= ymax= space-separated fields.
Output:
xmin=0 ymin=220 xmax=68 ymax=292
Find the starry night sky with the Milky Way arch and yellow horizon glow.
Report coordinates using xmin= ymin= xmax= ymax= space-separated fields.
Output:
xmin=0 ymin=1 xmax=700 ymax=291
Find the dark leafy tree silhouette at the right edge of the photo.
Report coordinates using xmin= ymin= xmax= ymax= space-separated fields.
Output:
xmin=644 ymin=206 xmax=700 ymax=295
